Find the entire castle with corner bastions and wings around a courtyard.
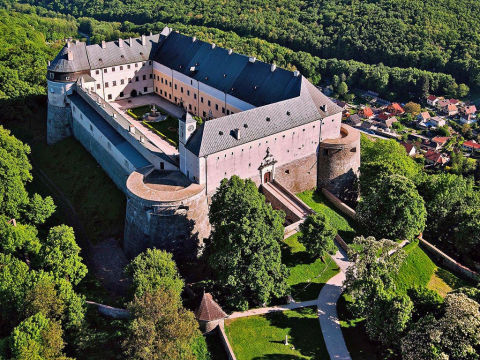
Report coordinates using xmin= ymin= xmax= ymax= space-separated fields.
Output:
xmin=47 ymin=28 xmax=360 ymax=256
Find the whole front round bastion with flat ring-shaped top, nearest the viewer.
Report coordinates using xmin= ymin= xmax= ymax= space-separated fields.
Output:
xmin=124 ymin=167 xmax=210 ymax=258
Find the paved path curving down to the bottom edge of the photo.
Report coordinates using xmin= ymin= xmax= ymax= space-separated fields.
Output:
xmin=317 ymin=248 xmax=351 ymax=360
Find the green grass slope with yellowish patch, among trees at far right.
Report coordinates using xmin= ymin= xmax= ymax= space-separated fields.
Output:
xmin=394 ymin=242 xmax=468 ymax=297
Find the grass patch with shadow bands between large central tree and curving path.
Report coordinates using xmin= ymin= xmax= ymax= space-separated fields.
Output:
xmin=282 ymin=233 xmax=339 ymax=301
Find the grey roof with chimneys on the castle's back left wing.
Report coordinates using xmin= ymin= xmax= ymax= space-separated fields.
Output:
xmin=87 ymin=34 xmax=165 ymax=69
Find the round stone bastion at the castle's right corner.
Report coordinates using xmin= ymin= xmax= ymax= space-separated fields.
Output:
xmin=317 ymin=124 xmax=360 ymax=201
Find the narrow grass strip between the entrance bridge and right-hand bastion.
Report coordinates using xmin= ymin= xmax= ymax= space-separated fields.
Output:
xmin=297 ymin=190 xmax=356 ymax=243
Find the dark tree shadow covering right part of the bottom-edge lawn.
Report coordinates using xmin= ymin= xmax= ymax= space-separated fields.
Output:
xmin=255 ymin=307 xmax=328 ymax=360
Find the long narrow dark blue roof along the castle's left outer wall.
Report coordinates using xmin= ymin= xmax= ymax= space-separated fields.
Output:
xmin=69 ymin=93 xmax=150 ymax=169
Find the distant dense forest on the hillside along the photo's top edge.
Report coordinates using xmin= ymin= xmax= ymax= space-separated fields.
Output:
xmin=5 ymin=0 xmax=480 ymax=85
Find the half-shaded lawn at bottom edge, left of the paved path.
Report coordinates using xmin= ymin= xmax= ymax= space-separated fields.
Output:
xmin=226 ymin=308 xmax=329 ymax=360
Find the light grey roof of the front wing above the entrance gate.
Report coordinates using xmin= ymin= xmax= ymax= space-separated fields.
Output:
xmin=186 ymin=77 xmax=342 ymax=157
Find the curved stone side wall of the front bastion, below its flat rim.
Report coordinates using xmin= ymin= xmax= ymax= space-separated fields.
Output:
xmin=123 ymin=193 xmax=210 ymax=258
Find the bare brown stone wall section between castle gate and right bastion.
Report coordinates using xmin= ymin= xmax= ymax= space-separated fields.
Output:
xmin=275 ymin=153 xmax=317 ymax=194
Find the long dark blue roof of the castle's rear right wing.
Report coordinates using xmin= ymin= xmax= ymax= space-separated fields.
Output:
xmin=154 ymin=32 xmax=301 ymax=106
